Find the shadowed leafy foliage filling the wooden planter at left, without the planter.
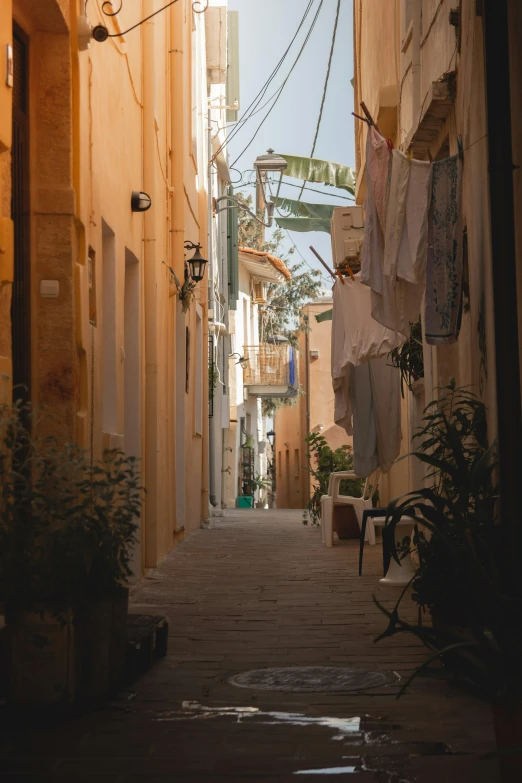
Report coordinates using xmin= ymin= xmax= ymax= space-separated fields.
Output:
xmin=0 ymin=403 xmax=143 ymax=611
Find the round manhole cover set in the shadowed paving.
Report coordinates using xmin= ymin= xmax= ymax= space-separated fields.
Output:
xmin=229 ymin=666 xmax=400 ymax=693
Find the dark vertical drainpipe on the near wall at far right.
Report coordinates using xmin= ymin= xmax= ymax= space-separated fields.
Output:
xmin=482 ymin=0 xmax=522 ymax=563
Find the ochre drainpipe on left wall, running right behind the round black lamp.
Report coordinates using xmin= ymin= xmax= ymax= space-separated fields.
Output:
xmin=142 ymin=0 xmax=158 ymax=568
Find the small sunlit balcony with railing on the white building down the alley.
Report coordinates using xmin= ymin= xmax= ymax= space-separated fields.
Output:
xmin=243 ymin=343 xmax=297 ymax=397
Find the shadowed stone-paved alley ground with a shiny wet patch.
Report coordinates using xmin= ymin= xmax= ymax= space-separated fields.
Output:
xmin=0 ymin=511 xmax=498 ymax=783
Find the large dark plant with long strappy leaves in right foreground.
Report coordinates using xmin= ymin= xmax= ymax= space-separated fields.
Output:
xmin=376 ymin=381 xmax=522 ymax=700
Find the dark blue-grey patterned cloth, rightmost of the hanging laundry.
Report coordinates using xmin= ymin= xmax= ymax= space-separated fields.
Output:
xmin=425 ymin=155 xmax=463 ymax=345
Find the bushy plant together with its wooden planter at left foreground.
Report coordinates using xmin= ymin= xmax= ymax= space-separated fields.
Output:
xmin=0 ymin=404 xmax=143 ymax=705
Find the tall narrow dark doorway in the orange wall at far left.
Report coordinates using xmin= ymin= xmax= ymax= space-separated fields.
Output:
xmin=11 ymin=25 xmax=31 ymax=400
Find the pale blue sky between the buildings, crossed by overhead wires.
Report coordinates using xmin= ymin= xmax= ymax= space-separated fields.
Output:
xmin=228 ymin=0 xmax=355 ymax=287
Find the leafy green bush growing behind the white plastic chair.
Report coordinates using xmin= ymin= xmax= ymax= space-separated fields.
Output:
xmin=303 ymin=432 xmax=363 ymax=525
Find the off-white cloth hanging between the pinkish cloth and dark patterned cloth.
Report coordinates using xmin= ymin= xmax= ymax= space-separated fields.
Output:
xmin=372 ymin=150 xmax=431 ymax=340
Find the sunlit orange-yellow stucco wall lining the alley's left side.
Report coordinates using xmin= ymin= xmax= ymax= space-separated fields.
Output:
xmin=0 ymin=0 xmax=208 ymax=572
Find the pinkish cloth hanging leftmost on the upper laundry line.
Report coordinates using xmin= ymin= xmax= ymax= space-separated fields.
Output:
xmin=361 ymin=125 xmax=391 ymax=294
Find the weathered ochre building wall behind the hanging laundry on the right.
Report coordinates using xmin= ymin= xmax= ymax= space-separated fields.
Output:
xmin=354 ymin=0 xmax=521 ymax=516
